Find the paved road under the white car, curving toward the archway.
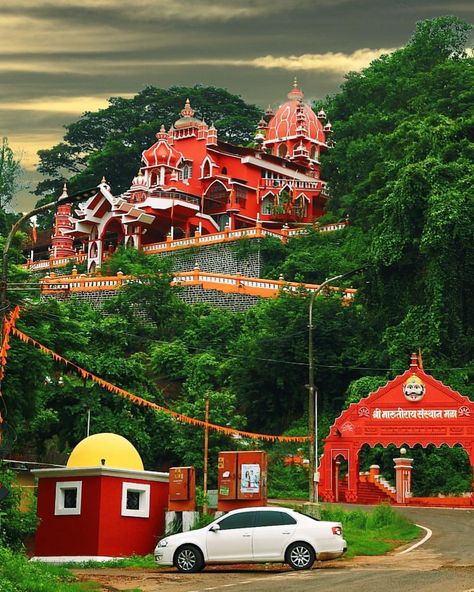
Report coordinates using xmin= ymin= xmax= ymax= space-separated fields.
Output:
xmin=75 ymin=508 xmax=474 ymax=592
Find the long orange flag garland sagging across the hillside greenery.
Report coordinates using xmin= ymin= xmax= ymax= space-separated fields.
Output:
xmin=6 ymin=314 xmax=311 ymax=442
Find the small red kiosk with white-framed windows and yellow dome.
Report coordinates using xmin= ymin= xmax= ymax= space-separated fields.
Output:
xmin=33 ymin=433 xmax=169 ymax=563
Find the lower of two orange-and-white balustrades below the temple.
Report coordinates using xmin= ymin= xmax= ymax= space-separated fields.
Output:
xmin=40 ymin=268 xmax=357 ymax=303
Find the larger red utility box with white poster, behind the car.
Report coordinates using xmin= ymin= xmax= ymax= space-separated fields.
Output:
xmin=218 ymin=450 xmax=267 ymax=512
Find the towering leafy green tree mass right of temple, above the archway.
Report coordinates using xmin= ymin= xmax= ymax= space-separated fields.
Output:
xmin=323 ymin=17 xmax=474 ymax=367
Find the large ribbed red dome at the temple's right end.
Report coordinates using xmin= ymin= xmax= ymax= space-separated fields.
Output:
xmin=265 ymin=81 xmax=326 ymax=145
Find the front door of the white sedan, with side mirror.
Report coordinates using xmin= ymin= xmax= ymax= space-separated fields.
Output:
xmin=206 ymin=512 xmax=255 ymax=562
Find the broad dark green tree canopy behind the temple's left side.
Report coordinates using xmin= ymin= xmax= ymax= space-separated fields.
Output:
xmin=36 ymin=85 xmax=261 ymax=201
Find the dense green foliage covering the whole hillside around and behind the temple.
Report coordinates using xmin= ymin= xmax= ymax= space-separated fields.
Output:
xmin=3 ymin=17 xmax=474 ymax=540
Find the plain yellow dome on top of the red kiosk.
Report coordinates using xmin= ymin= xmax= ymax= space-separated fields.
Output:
xmin=67 ymin=433 xmax=144 ymax=471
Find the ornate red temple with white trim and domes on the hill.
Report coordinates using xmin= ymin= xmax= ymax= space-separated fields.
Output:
xmin=52 ymin=81 xmax=331 ymax=272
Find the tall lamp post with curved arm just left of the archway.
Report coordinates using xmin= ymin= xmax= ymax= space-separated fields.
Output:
xmin=308 ymin=267 xmax=365 ymax=503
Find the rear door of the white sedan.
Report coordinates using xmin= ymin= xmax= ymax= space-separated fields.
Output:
xmin=253 ymin=510 xmax=297 ymax=561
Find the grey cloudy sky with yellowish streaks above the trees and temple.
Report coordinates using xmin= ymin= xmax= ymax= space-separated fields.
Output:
xmin=0 ymin=0 xmax=474 ymax=208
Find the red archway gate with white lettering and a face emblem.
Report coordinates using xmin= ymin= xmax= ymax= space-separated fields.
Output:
xmin=319 ymin=354 xmax=474 ymax=505
